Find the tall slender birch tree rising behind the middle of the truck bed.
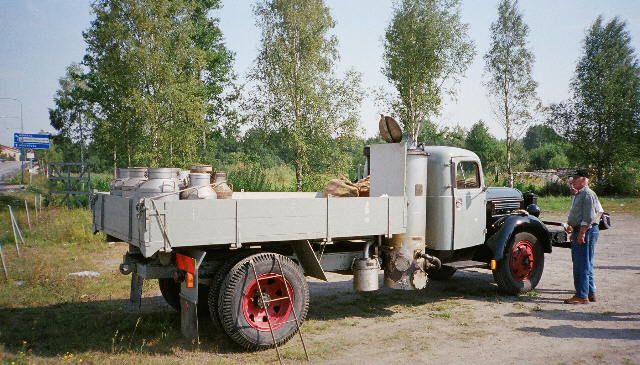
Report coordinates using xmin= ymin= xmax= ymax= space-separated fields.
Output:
xmin=247 ymin=0 xmax=364 ymax=191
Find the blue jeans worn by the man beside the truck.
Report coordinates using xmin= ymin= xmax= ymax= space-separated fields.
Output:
xmin=571 ymin=224 xmax=600 ymax=298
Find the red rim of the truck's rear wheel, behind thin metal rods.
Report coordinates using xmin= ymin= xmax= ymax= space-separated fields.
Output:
xmin=242 ymin=273 xmax=294 ymax=331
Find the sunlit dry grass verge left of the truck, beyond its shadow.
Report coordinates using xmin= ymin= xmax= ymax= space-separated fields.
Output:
xmin=0 ymin=173 xmax=134 ymax=308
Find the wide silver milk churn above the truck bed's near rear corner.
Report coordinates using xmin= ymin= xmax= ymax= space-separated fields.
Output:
xmin=136 ymin=167 xmax=184 ymax=202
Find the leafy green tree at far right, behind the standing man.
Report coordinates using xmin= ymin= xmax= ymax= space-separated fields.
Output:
xmin=552 ymin=17 xmax=640 ymax=192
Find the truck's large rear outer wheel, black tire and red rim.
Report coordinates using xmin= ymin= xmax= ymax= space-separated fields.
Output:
xmin=218 ymin=253 xmax=309 ymax=350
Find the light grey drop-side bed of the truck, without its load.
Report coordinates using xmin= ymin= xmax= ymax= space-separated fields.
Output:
xmin=92 ymin=193 xmax=407 ymax=257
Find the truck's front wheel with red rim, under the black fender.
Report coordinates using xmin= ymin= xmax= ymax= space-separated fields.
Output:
xmin=493 ymin=232 xmax=544 ymax=295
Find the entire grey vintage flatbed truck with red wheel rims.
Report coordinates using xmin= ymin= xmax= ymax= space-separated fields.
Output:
xmin=93 ymin=143 xmax=567 ymax=349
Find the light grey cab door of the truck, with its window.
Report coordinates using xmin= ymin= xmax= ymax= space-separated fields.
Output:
xmin=452 ymin=158 xmax=486 ymax=250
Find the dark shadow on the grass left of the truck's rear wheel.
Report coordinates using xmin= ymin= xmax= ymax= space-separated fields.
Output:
xmin=0 ymin=296 xmax=242 ymax=357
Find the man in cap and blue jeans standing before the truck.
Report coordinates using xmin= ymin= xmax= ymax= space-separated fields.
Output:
xmin=564 ymin=170 xmax=600 ymax=304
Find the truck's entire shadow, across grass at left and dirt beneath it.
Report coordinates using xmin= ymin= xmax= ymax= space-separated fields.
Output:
xmin=0 ymin=271 xmax=515 ymax=357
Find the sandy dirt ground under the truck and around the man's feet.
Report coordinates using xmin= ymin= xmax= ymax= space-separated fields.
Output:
xmin=136 ymin=215 xmax=640 ymax=364
